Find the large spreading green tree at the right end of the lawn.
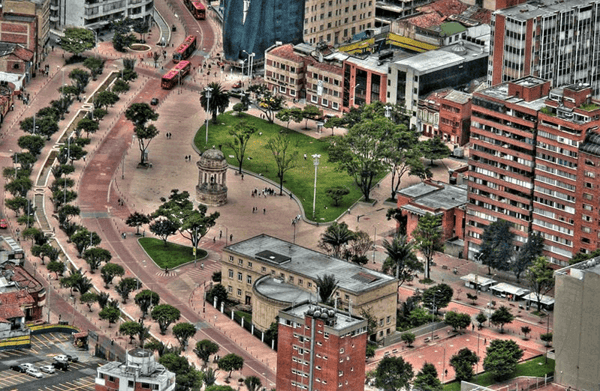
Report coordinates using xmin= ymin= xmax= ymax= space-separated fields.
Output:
xmin=329 ymin=118 xmax=394 ymax=202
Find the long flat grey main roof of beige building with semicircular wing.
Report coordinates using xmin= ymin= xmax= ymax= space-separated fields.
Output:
xmin=226 ymin=234 xmax=395 ymax=292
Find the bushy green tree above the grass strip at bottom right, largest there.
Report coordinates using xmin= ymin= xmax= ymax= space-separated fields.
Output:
xmin=483 ymin=339 xmax=523 ymax=381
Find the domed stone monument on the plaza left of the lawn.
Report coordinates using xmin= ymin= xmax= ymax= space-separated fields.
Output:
xmin=196 ymin=145 xmax=227 ymax=206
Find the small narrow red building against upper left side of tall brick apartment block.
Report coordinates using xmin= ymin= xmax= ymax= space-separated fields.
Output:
xmin=439 ymin=91 xmax=471 ymax=145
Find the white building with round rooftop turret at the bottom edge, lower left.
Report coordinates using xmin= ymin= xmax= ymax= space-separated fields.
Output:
xmin=95 ymin=348 xmax=176 ymax=391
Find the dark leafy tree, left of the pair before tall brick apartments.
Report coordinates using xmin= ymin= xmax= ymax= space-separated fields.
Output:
xmin=477 ymin=219 xmax=515 ymax=274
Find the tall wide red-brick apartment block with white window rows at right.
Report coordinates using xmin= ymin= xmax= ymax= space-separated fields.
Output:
xmin=465 ymin=77 xmax=600 ymax=265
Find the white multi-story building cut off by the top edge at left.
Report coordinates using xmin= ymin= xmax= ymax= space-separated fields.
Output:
xmin=50 ymin=0 xmax=154 ymax=30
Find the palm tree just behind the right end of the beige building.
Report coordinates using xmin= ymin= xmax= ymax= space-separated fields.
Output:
xmin=382 ymin=235 xmax=423 ymax=285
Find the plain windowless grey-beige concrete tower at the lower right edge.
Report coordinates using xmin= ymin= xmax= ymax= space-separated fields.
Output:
xmin=552 ymin=258 xmax=600 ymax=390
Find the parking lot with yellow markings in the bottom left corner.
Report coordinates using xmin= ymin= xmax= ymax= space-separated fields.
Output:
xmin=0 ymin=333 xmax=104 ymax=391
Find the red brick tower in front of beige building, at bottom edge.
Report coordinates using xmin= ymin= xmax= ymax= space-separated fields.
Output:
xmin=277 ymin=302 xmax=367 ymax=391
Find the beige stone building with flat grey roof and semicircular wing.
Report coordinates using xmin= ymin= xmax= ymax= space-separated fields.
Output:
xmin=221 ymin=234 xmax=398 ymax=342
